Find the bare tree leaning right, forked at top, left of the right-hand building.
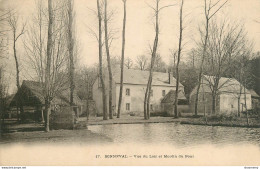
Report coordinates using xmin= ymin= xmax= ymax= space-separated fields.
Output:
xmin=195 ymin=0 xmax=228 ymax=115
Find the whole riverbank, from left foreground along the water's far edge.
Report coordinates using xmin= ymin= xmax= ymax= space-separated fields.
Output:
xmin=0 ymin=116 xmax=260 ymax=144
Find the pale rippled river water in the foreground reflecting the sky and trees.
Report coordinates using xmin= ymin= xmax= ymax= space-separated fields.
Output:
xmin=88 ymin=123 xmax=260 ymax=147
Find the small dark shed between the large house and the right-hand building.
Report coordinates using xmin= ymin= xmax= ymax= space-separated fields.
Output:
xmin=161 ymin=90 xmax=189 ymax=116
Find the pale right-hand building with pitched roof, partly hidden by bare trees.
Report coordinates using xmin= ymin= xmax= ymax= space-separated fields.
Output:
xmin=190 ymin=75 xmax=252 ymax=114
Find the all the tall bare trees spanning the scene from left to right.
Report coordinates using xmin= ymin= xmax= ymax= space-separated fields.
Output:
xmin=0 ymin=0 xmax=257 ymax=128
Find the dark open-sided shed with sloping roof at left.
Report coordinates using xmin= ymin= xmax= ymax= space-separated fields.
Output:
xmin=10 ymin=80 xmax=83 ymax=120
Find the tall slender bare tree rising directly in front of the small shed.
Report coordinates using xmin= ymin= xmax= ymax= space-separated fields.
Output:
xmin=174 ymin=0 xmax=184 ymax=118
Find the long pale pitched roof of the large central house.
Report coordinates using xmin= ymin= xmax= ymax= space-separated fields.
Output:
xmin=109 ymin=68 xmax=183 ymax=86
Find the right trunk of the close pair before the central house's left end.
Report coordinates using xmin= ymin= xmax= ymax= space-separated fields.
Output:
xmin=104 ymin=0 xmax=113 ymax=119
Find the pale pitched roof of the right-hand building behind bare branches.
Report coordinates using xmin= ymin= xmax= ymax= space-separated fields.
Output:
xmin=191 ymin=75 xmax=249 ymax=95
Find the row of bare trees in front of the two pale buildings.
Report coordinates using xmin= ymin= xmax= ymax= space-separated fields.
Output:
xmin=88 ymin=0 xmax=258 ymax=119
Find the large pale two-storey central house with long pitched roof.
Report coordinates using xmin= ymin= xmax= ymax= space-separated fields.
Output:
xmin=93 ymin=68 xmax=184 ymax=115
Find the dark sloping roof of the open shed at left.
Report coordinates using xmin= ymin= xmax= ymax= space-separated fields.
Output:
xmin=22 ymin=80 xmax=82 ymax=105
